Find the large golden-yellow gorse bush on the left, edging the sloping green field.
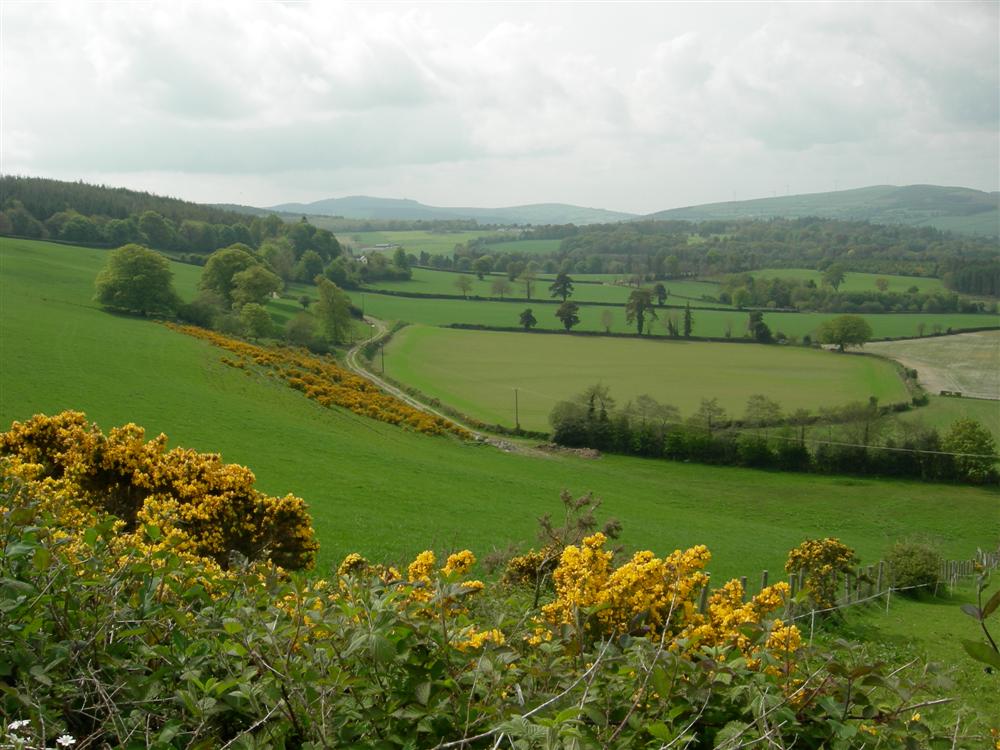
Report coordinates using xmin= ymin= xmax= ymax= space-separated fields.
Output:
xmin=0 ymin=411 xmax=319 ymax=570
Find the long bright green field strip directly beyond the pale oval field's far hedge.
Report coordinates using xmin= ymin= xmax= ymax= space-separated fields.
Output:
xmin=342 ymin=289 xmax=1000 ymax=339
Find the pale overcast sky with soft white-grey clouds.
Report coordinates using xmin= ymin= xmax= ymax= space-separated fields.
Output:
xmin=0 ymin=0 xmax=1000 ymax=213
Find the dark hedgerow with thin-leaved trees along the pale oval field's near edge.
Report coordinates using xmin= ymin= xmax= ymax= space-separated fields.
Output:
xmin=549 ymin=386 xmax=997 ymax=484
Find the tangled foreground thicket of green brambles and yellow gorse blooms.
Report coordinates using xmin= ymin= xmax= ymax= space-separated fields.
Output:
xmin=0 ymin=450 xmax=968 ymax=750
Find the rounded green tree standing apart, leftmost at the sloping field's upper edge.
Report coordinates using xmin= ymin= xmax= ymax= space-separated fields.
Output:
xmin=95 ymin=244 xmax=179 ymax=315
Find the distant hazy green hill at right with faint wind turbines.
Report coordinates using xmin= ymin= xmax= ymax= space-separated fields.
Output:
xmin=643 ymin=185 xmax=1000 ymax=237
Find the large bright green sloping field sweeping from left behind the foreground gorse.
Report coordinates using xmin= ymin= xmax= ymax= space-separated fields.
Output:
xmin=0 ymin=239 xmax=1000 ymax=577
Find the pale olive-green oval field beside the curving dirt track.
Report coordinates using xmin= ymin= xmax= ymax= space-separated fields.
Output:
xmin=385 ymin=326 xmax=907 ymax=430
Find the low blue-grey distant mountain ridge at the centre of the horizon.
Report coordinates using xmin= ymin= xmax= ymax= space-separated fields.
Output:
xmin=270 ymin=195 xmax=636 ymax=224
